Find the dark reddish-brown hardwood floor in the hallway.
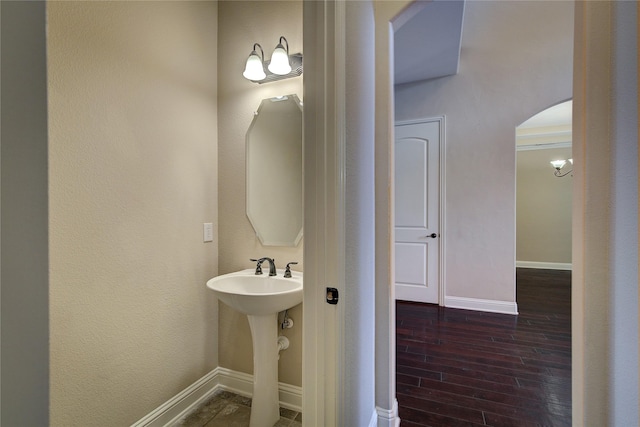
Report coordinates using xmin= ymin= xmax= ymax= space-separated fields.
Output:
xmin=396 ymin=269 xmax=571 ymax=427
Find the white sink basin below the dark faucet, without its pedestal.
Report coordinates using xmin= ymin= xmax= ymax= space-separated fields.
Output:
xmin=207 ymin=269 xmax=302 ymax=316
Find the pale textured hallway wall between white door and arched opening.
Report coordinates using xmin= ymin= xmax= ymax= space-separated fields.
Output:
xmin=396 ymin=1 xmax=573 ymax=302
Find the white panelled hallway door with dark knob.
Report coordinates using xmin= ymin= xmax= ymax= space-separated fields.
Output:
xmin=395 ymin=119 xmax=441 ymax=304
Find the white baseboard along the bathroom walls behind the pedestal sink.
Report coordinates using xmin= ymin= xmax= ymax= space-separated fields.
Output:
xmin=131 ymin=367 xmax=302 ymax=427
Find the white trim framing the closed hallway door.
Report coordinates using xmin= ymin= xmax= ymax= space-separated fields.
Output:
xmin=392 ymin=115 xmax=447 ymax=306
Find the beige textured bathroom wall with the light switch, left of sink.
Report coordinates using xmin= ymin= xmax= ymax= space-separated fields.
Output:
xmin=47 ymin=2 xmax=217 ymax=426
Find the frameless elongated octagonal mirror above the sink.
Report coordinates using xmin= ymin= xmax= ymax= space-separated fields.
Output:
xmin=246 ymin=95 xmax=303 ymax=246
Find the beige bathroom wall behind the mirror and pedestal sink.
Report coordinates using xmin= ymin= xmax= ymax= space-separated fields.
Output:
xmin=218 ymin=1 xmax=303 ymax=386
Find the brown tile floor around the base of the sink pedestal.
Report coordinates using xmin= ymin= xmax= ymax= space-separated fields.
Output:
xmin=173 ymin=390 xmax=302 ymax=427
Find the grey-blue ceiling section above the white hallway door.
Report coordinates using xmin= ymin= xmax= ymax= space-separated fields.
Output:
xmin=394 ymin=0 xmax=464 ymax=84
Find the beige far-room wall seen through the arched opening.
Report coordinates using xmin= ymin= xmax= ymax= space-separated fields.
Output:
xmin=516 ymin=148 xmax=573 ymax=264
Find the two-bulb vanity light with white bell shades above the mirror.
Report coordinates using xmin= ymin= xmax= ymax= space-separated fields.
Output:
xmin=242 ymin=36 xmax=302 ymax=84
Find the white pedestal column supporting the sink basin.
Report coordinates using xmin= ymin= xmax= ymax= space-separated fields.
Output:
xmin=247 ymin=313 xmax=280 ymax=427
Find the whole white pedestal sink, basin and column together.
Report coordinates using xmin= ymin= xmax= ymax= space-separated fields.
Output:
xmin=207 ymin=269 xmax=302 ymax=427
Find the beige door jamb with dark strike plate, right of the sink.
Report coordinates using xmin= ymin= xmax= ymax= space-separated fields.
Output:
xmin=302 ymin=1 xmax=346 ymax=426
